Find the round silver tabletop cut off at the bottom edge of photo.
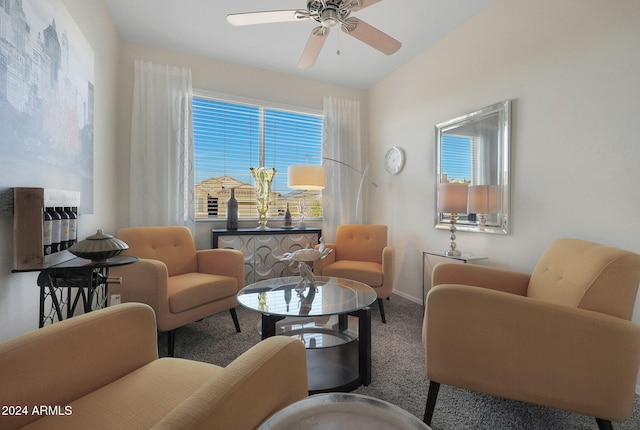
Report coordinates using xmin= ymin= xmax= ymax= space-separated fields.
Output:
xmin=258 ymin=393 xmax=430 ymax=430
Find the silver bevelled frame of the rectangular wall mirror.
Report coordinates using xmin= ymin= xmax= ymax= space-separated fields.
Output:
xmin=434 ymin=100 xmax=511 ymax=234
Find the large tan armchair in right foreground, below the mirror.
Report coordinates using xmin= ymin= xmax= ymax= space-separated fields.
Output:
xmin=423 ymin=239 xmax=640 ymax=429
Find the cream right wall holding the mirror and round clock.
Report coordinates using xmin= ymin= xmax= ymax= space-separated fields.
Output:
xmin=369 ymin=0 xmax=640 ymax=386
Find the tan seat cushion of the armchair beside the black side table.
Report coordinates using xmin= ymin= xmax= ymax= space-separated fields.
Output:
xmin=167 ymin=272 xmax=238 ymax=313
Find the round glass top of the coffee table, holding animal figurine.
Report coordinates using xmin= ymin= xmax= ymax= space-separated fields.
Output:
xmin=238 ymin=276 xmax=377 ymax=317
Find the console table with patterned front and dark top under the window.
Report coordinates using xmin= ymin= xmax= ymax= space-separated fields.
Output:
xmin=211 ymin=227 xmax=322 ymax=284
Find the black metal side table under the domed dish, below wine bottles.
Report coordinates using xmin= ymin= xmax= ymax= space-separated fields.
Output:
xmin=38 ymin=255 xmax=138 ymax=327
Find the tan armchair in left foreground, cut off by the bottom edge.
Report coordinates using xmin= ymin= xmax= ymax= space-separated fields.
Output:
xmin=0 ymin=303 xmax=308 ymax=430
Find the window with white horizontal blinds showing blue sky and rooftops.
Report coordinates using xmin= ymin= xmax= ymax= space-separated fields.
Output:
xmin=193 ymin=94 xmax=322 ymax=219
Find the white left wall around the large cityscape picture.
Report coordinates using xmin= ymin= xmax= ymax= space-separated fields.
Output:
xmin=0 ymin=0 xmax=120 ymax=341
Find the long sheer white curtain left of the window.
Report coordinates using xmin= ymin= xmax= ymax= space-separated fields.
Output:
xmin=129 ymin=60 xmax=195 ymax=232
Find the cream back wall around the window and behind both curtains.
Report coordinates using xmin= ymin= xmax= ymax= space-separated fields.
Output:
xmin=112 ymin=42 xmax=368 ymax=249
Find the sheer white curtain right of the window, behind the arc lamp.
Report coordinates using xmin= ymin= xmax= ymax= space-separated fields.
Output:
xmin=322 ymin=97 xmax=367 ymax=243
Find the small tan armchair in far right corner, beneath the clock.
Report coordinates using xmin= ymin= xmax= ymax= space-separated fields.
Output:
xmin=313 ymin=224 xmax=395 ymax=324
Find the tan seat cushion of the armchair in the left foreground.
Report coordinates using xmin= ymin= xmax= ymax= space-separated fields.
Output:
xmin=25 ymin=358 xmax=223 ymax=430
